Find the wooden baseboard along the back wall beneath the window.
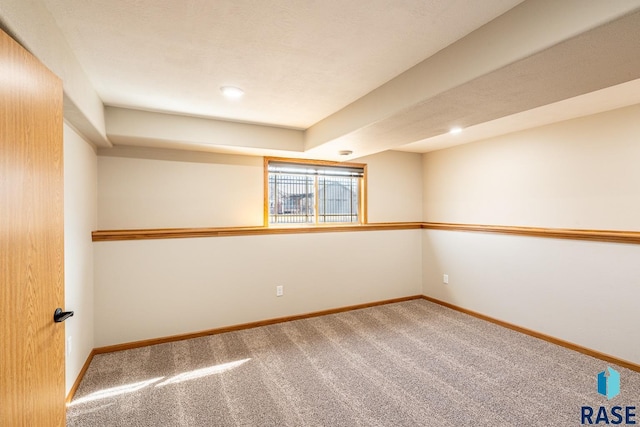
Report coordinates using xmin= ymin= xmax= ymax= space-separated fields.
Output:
xmin=93 ymin=295 xmax=422 ymax=354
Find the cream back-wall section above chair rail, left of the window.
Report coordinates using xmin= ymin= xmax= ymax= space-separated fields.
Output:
xmin=98 ymin=148 xmax=263 ymax=230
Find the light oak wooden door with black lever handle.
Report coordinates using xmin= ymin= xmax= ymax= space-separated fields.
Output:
xmin=0 ymin=31 xmax=65 ymax=427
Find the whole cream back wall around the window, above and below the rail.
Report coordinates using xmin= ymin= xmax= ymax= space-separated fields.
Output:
xmin=94 ymin=148 xmax=422 ymax=347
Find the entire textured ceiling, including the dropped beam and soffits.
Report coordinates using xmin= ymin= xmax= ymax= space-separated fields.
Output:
xmin=11 ymin=0 xmax=640 ymax=160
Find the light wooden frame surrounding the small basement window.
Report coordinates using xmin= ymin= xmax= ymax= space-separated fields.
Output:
xmin=262 ymin=157 xmax=368 ymax=228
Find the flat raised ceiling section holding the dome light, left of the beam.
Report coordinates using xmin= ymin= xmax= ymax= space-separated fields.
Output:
xmin=38 ymin=0 xmax=522 ymax=129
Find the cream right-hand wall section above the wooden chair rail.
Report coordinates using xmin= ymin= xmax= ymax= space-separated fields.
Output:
xmin=423 ymin=105 xmax=640 ymax=230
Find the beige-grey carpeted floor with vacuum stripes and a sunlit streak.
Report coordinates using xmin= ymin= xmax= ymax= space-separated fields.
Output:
xmin=67 ymin=300 xmax=640 ymax=427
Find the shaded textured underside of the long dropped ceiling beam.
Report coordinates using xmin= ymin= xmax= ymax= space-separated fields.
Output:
xmin=312 ymin=12 xmax=640 ymax=157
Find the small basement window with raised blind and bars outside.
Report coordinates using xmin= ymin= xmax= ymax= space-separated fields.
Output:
xmin=265 ymin=157 xmax=366 ymax=225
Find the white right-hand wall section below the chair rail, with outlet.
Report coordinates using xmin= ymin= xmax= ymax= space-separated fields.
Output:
xmin=423 ymin=230 xmax=640 ymax=363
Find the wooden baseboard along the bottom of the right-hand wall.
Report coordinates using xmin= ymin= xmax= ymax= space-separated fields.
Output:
xmin=422 ymin=295 xmax=640 ymax=372
